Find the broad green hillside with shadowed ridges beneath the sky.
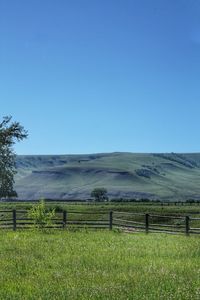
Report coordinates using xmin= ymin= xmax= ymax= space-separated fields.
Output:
xmin=15 ymin=152 xmax=200 ymax=201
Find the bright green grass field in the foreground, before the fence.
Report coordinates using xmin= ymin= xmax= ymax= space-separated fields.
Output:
xmin=0 ymin=231 xmax=200 ymax=300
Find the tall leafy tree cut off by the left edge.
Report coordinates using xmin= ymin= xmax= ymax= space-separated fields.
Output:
xmin=0 ymin=116 xmax=28 ymax=198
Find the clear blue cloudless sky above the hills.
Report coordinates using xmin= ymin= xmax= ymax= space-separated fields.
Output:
xmin=0 ymin=0 xmax=200 ymax=154
